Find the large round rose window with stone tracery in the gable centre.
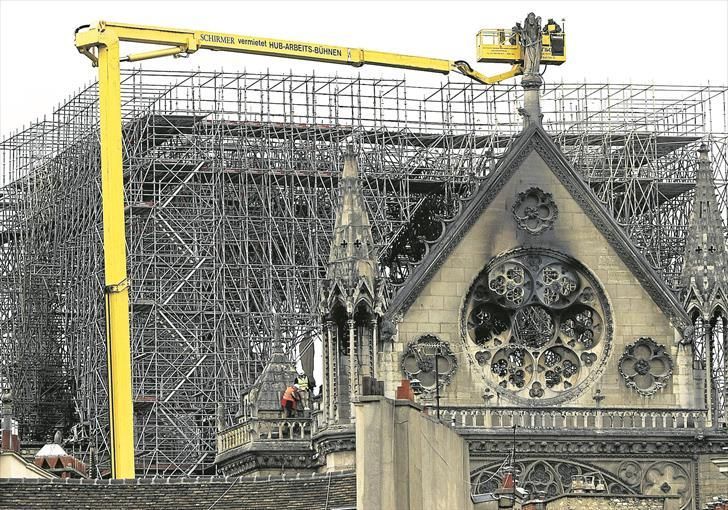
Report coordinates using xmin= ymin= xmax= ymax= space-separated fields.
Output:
xmin=461 ymin=248 xmax=612 ymax=404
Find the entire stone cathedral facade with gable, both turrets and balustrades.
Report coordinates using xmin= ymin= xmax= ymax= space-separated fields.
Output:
xmin=217 ymin=115 xmax=728 ymax=509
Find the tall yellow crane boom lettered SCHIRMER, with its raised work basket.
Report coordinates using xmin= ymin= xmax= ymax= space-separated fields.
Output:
xmin=75 ymin=16 xmax=566 ymax=478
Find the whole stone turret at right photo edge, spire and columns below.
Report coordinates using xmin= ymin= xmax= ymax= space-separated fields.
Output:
xmin=680 ymin=144 xmax=728 ymax=425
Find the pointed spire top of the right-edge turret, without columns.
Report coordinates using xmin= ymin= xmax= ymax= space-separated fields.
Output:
xmin=680 ymin=144 xmax=728 ymax=306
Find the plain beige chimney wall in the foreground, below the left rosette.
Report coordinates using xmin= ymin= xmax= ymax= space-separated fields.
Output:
xmin=355 ymin=397 xmax=472 ymax=510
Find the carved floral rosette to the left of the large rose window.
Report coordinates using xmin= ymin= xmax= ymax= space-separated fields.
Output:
xmin=401 ymin=335 xmax=458 ymax=397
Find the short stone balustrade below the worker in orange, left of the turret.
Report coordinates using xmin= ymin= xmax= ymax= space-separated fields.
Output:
xmin=217 ymin=418 xmax=311 ymax=453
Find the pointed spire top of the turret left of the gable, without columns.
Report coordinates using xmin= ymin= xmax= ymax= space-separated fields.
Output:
xmin=326 ymin=149 xmax=377 ymax=312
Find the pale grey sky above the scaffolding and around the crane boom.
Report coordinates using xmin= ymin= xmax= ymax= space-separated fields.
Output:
xmin=0 ymin=0 xmax=728 ymax=138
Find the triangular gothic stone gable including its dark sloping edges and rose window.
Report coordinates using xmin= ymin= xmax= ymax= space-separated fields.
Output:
xmin=388 ymin=127 xmax=699 ymax=408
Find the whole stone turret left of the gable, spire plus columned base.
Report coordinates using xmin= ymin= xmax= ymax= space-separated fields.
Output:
xmin=320 ymin=150 xmax=383 ymax=423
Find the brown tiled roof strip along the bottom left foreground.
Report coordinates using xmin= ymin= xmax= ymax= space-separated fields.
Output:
xmin=0 ymin=472 xmax=356 ymax=510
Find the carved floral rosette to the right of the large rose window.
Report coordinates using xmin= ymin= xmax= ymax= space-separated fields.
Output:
xmin=619 ymin=337 xmax=672 ymax=396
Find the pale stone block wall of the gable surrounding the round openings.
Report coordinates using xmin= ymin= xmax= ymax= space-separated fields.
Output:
xmin=379 ymin=148 xmax=700 ymax=408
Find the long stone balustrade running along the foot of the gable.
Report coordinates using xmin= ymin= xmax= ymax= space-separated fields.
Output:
xmin=440 ymin=407 xmax=707 ymax=430
